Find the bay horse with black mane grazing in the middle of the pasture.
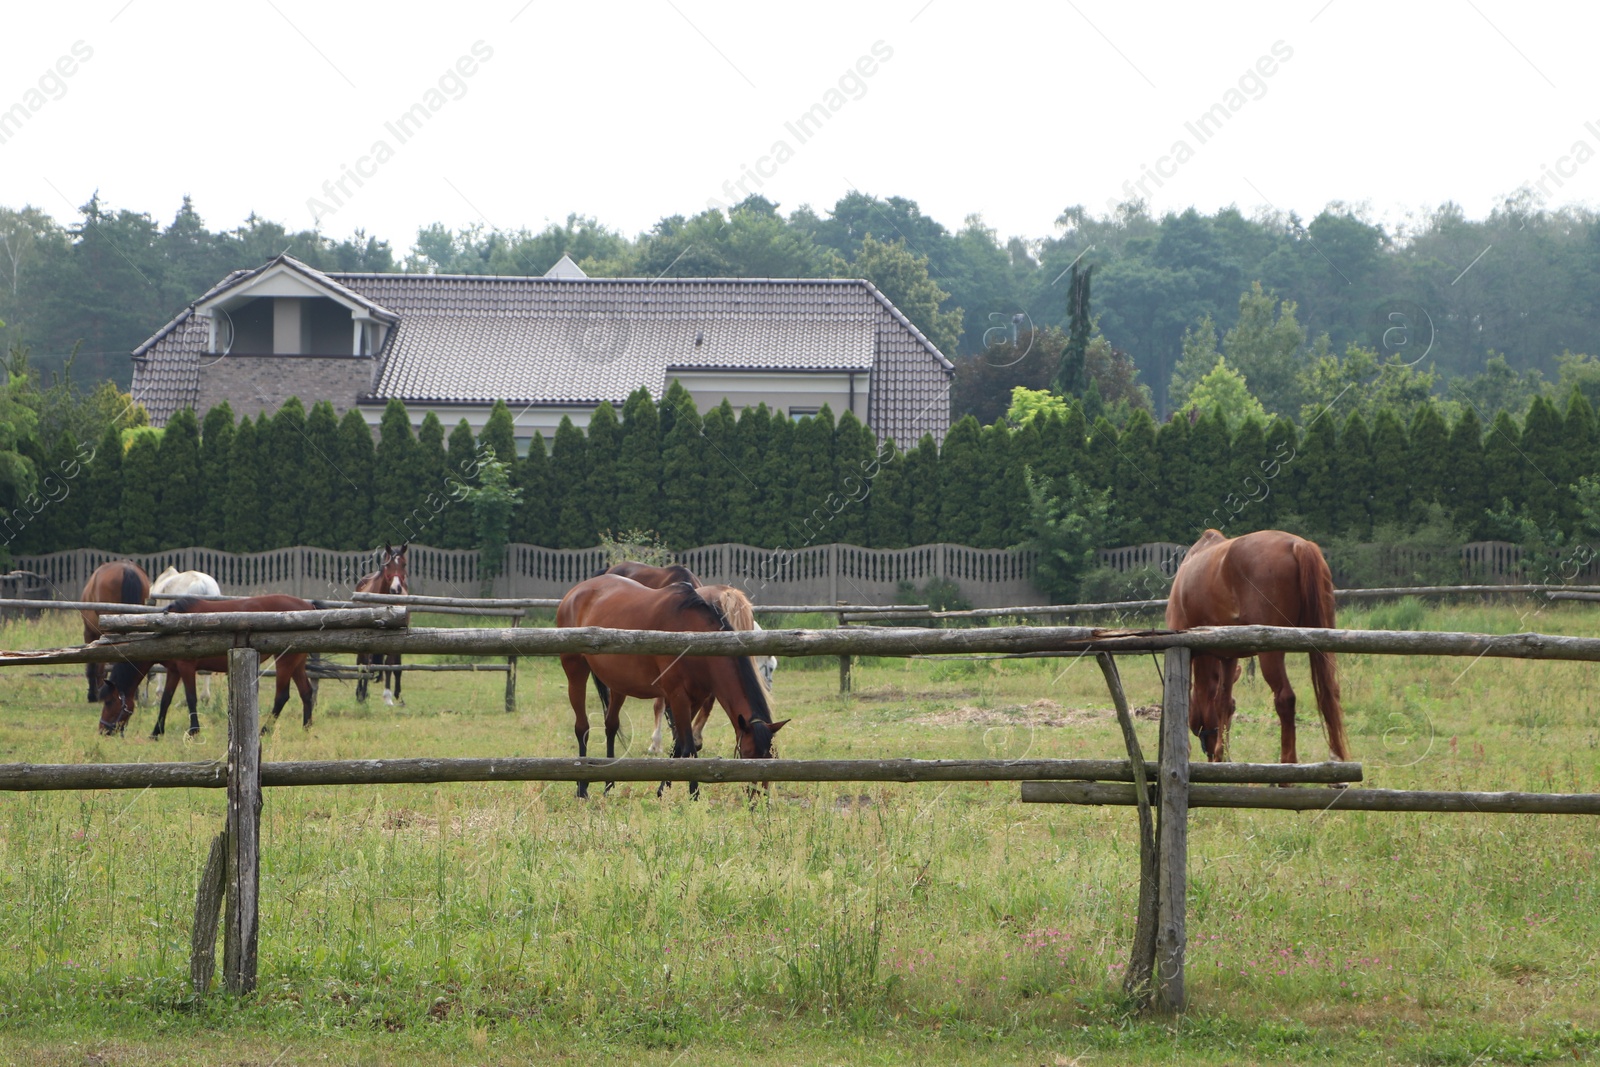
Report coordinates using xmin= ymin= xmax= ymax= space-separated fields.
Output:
xmin=555 ymin=574 xmax=789 ymax=797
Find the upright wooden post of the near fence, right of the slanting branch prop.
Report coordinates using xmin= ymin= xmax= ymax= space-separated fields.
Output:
xmin=1155 ymin=648 xmax=1189 ymax=1014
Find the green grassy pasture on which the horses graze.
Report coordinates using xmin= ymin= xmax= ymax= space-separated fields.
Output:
xmin=0 ymin=601 xmax=1600 ymax=1067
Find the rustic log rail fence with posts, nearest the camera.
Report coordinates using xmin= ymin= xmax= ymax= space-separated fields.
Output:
xmin=0 ymin=608 xmax=1600 ymax=1013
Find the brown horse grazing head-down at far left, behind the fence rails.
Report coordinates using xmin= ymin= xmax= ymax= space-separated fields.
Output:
xmin=101 ymin=593 xmax=317 ymax=741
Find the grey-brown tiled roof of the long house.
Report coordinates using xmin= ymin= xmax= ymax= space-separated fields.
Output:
xmin=134 ymin=264 xmax=952 ymax=446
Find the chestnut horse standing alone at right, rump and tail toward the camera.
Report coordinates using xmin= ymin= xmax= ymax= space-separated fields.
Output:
xmin=1166 ymin=530 xmax=1350 ymax=763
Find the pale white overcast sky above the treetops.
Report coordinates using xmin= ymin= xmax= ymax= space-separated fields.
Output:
xmin=0 ymin=0 xmax=1600 ymax=251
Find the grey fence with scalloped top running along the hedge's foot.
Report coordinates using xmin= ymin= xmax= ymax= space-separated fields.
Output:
xmin=15 ymin=541 xmax=1600 ymax=608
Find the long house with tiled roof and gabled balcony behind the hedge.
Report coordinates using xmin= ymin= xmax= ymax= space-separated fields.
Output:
xmin=133 ymin=256 xmax=954 ymax=446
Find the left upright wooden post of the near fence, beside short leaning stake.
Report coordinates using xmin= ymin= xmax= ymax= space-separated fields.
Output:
xmin=222 ymin=648 xmax=261 ymax=993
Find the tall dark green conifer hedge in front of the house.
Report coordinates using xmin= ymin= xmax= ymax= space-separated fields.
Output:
xmin=3 ymin=382 xmax=1600 ymax=553
